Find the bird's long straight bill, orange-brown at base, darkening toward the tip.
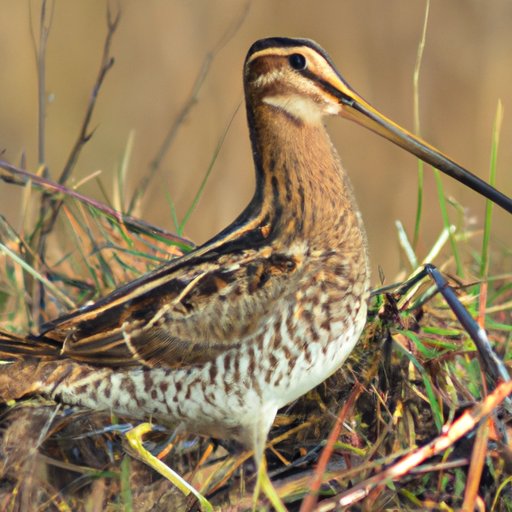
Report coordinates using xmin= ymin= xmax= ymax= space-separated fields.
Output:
xmin=330 ymin=77 xmax=512 ymax=213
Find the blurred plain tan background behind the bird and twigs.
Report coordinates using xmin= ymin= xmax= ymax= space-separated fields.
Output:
xmin=0 ymin=0 xmax=512 ymax=284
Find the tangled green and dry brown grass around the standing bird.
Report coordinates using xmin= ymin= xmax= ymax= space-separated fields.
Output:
xmin=0 ymin=4 xmax=512 ymax=511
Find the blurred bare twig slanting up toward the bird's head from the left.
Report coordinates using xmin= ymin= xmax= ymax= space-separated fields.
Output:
xmin=128 ymin=1 xmax=250 ymax=213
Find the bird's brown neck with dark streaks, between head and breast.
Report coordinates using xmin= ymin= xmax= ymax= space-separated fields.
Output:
xmin=244 ymin=103 xmax=367 ymax=258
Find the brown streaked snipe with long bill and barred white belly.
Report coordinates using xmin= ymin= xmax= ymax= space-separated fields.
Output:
xmin=0 ymin=37 xmax=510 ymax=508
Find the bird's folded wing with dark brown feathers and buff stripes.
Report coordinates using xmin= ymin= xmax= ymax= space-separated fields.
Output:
xmin=39 ymin=247 xmax=298 ymax=367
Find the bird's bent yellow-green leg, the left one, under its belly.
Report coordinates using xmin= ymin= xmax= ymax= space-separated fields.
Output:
xmin=125 ymin=423 xmax=213 ymax=512
